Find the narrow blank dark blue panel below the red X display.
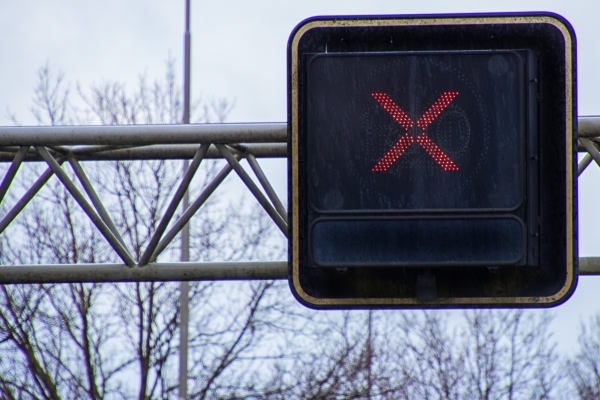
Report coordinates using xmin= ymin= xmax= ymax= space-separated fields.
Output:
xmin=309 ymin=216 xmax=525 ymax=268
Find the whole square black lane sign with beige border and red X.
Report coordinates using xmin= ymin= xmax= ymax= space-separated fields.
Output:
xmin=288 ymin=14 xmax=577 ymax=308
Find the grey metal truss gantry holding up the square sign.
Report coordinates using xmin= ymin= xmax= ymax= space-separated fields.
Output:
xmin=0 ymin=117 xmax=600 ymax=283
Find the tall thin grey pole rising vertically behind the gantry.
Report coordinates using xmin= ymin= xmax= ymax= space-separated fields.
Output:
xmin=179 ymin=0 xmax=191 ymax=399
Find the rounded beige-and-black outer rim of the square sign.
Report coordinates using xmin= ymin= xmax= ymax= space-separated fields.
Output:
xmin=288 ymin=14 xmax=580 ymax=308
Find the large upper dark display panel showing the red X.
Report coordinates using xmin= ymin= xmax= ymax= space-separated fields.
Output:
xmin=306 ymin=51 xmax=525 ymax=213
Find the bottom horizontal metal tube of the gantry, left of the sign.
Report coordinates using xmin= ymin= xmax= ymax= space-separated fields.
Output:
xmin=0 ymin=261 xmax=288 ymax=284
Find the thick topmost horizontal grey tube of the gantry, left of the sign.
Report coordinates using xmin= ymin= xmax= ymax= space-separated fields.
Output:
xmin=0 ymin=123 xmax=287 ymax=146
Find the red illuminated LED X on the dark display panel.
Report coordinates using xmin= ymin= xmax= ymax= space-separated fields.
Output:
xmin=371 ymin=92 xmax=458 ymax=171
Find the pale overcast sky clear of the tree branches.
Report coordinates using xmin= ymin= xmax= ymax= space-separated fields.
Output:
xmin=0 ymin=0 xmax=600 ymax=349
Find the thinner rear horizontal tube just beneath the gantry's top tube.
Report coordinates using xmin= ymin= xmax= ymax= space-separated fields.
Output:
xmin=0 ymin=143 xmax=287 ymax=162
